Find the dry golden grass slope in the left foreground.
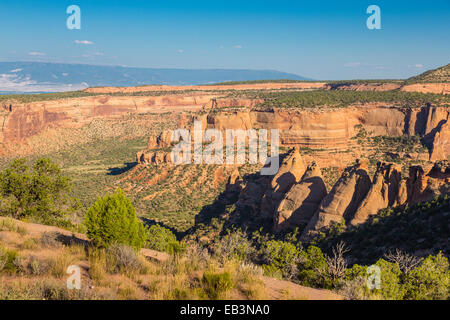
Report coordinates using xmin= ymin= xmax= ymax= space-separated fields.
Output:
xmin=0 ymin=222 xmax=342 ymax=300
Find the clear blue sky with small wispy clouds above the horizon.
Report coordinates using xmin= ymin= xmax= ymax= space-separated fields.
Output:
xmin=0 ymin=0 xmax=450 ymax=80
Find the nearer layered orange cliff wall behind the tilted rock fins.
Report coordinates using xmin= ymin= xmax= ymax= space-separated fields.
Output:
xmin=137 ymin=103 xmax=450 ymax=168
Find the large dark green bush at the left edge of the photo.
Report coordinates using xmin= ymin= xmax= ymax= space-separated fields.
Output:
xmin=0 ymin=158 xmax=79 ymax=224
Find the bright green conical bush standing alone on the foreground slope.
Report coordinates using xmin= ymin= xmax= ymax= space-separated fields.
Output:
xmin=84 ymin=189 xmax=146 ymax=249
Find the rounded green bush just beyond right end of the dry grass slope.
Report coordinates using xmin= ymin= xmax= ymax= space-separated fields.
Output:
xmin=262 ymin=240 xmax=299 ymax=278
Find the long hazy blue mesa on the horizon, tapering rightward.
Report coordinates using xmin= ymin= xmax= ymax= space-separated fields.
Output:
xmin=0 ymin=62 xmax=311 ymax=93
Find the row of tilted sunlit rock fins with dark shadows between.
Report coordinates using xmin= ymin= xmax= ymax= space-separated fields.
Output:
xmin=216 ymin=149 xmax=450 ymax=241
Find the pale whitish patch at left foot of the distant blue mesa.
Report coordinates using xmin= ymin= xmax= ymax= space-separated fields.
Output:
xmin=0 ymin=73 xmax=89 ymax=92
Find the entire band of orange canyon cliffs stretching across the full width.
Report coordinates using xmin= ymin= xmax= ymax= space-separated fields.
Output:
xmin=0 ymin=94 xmax=450 ymax=166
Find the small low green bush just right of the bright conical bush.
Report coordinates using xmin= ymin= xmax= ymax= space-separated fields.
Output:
xmin=145 ymin=224 xmax=181 ymax=253
